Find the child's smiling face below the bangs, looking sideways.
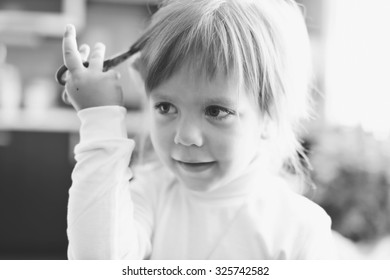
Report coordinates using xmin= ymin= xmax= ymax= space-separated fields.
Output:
xmin=149 ymin=66 xmax=263 ymax=190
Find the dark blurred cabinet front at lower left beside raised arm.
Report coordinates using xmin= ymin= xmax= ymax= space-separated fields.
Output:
xmin=0 ymin=132 xmax=73 ymax=259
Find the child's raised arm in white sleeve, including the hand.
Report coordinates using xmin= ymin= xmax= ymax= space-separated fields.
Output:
xmin=63 ymin=26 xmax=152 ymax=259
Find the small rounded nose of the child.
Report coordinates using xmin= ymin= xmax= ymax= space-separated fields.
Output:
xmin=174 ymin=117 xmax=203 ymax=147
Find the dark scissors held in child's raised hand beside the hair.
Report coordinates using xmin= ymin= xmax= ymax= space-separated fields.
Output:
xmin=55 ymin=41 xmax=141 ymax=86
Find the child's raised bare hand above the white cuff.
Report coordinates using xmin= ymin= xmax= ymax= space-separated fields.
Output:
xmin=62 ymin=25 xmax=123 ymax=110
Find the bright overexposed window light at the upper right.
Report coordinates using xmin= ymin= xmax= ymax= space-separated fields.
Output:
xmin=325 ymin=0 xmax=390 ymax=139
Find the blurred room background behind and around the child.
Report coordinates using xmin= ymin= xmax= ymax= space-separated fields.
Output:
xmin=0 ymin=0 xmax=390 ymax=259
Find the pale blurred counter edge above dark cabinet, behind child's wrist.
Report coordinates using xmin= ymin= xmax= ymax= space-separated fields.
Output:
xmin=0 ymin=108 xmax=142 ymax=134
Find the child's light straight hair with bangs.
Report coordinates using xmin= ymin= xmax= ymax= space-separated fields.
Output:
xmin=136 ymin=0 xmax=311 ymax=190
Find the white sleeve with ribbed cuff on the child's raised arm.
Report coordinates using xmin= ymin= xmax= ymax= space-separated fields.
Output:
xmin=67 ymin=106 xmax=151 ymax=259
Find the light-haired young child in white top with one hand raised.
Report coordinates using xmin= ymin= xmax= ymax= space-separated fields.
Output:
xmin=63 ymin=0 xmax=334 ymax=259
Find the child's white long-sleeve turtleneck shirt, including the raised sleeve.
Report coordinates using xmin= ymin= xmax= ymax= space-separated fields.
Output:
xmin=68 ymin=106 xmax=335 ymax=259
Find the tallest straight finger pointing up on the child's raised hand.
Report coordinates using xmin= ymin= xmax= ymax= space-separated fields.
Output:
xmin=62 ymin=24 xmax=83 ymax=71
